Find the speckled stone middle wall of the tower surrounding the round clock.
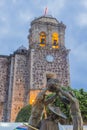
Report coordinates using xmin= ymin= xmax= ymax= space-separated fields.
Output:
xmin=31 ymin=49 xmax=70 ymax=89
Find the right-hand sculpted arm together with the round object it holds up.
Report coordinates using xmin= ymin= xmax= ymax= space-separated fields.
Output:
xmin=47 ymin=79 xmax=83 ymax=130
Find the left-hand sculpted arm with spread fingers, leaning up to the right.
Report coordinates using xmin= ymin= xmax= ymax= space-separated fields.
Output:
xmin=28 ymin=87 xmax=56 ymax=130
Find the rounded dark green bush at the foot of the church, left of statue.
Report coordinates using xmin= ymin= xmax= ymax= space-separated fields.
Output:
xmin=15 ymin=105 xmax=31 ymax=122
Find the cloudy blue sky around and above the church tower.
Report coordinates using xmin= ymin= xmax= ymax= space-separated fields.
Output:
xmin=0 ymin=0 xmax=87 ymax=91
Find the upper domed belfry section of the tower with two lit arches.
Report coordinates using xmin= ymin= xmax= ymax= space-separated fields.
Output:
xmin=28 ymin=15 xmax=66 ymax=49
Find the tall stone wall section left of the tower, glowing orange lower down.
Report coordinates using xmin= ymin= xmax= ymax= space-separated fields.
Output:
xmin=10 ymin=54 xmax=29 ymax=121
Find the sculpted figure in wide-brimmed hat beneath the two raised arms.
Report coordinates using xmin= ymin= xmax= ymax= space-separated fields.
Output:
xmin=40 ymin=105 xmax=66 ymax=130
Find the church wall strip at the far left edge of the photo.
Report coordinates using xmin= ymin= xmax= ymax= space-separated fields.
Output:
xmin=0 ymin=56 xmax=9 ymax=121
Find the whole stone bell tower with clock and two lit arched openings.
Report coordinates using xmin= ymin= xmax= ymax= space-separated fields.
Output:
xmin=28 ymin=16 xmax=70 ymax=103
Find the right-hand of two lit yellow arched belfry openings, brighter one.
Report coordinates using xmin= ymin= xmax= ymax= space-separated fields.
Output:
xmin=52 ymin=32 xmax=59 ymax=48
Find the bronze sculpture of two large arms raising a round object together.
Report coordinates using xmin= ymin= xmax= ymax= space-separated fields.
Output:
xmin=29 ymin=79 xmax=83 ymax=130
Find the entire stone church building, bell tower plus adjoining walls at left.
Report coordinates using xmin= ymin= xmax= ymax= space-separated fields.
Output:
xmin=0 ymin=16 xmax=70 ymax=121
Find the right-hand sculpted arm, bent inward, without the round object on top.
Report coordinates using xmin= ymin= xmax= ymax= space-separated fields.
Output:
xmin=59 ymin=88 xmax=83 ymax=130
